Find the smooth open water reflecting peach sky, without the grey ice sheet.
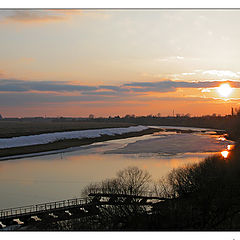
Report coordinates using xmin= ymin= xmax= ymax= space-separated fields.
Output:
xmin=0 ymin=128 xmax=234 ymax=208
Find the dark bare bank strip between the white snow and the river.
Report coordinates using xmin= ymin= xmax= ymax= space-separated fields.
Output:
xmin=0 ymin=128 xmax=163 ymax=161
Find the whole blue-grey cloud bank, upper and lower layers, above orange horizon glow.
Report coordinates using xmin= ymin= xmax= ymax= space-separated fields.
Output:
xmin=0 ymin=79 xmax=240 ymax=107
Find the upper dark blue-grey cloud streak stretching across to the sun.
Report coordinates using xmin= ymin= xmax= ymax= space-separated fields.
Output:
xmin=0 ymin=79 xmax=240 ymax=96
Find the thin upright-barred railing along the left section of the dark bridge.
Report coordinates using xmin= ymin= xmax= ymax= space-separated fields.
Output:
xmin=0 ymin=198 xmax=90 ymax=218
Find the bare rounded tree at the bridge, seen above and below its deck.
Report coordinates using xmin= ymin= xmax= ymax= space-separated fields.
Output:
xmin=79 ymin=167 xmax=151 ymax=230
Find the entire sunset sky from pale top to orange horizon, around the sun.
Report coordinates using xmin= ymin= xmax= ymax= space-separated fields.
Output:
xmin=0 ymin=9 xmax=240 ymax=117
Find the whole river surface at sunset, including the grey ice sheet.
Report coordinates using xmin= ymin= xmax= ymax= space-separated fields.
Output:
xmin=0 ymin=127 xmax=232 ymax=209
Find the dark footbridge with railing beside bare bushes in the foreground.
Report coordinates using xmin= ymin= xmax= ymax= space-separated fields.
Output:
xmin=0 ymin=192 xmax=167 ymax=228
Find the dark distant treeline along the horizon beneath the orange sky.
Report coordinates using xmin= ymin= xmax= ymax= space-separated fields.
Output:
xmin=1 ymin=114 xmax=240 ymax=140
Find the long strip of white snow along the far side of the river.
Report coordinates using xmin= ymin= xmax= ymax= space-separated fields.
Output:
xmin=0 ymin=125 xmax=149 ymax=149
